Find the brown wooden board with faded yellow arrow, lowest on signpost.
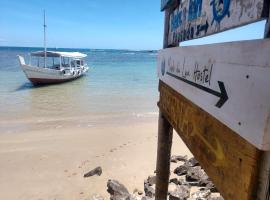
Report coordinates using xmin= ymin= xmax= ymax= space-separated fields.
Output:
xmin=159 ymin=81 xmax=261 ymax=200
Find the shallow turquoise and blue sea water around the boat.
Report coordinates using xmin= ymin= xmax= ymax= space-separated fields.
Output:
xmin=0 ymin=47 xmax=158 ymax=133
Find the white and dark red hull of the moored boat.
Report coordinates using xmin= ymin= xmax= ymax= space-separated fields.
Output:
xmin=22 ymin=65 xmax=88 ymax=85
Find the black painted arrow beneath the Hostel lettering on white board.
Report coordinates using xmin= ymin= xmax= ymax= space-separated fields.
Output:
xmin=167 ymin=72 xmax=229 ymax=108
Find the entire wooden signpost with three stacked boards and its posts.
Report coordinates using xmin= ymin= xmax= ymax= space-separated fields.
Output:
xmin=155 ymin=0 xmax=270 ymax=200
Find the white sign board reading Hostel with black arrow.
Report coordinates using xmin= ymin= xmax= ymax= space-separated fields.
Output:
xmin=158 ymin=39 xmax=270 ymax=150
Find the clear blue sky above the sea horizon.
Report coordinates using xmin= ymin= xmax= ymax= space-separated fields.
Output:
xmin=0 ymin=0 xmax=265 ymax=50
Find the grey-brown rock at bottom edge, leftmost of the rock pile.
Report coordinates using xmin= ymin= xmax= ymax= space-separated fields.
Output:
xmin=107 ymin=180 xmax=130 ymax=200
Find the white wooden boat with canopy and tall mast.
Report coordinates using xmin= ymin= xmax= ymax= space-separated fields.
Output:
xmin=18 ymin=11 xmax=89 ymax=85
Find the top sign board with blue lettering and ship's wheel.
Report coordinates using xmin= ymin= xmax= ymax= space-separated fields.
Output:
xmin=168 ymin=0 xmax=269 ymax=45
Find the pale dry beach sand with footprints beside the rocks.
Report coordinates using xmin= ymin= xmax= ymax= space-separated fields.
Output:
xmin=0 ymin=120 xmax=191 ymax=200
